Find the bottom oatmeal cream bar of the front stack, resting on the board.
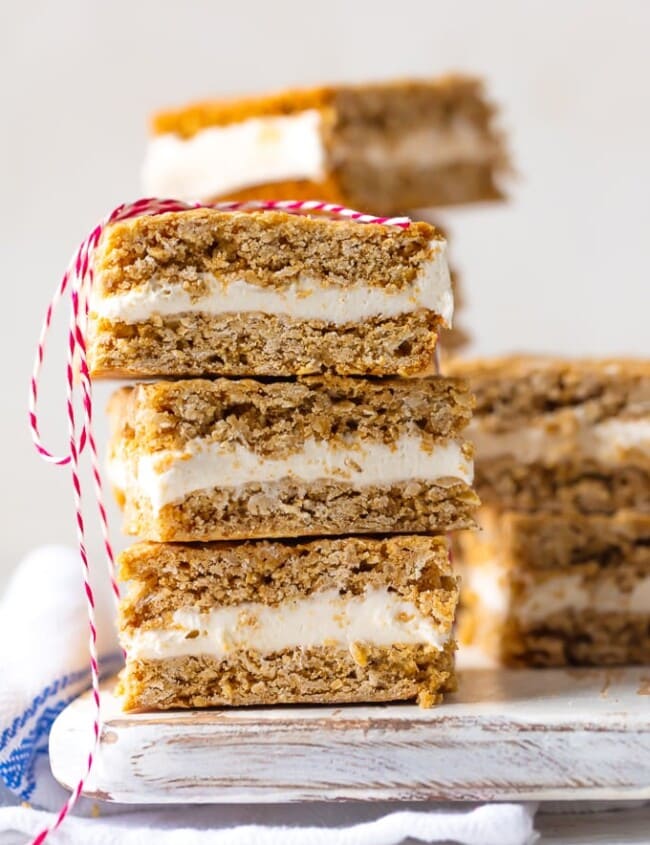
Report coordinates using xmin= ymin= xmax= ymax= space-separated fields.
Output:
xmin=119 ymin=535 xmax=458 ymax=710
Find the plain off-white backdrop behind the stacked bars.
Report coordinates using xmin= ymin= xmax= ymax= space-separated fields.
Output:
xmin=0 ymin=0 xmax=650 ymax=581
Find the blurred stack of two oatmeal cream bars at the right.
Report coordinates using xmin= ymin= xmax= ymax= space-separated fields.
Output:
xmin=451 ymin=356 xmax=650 ymax=666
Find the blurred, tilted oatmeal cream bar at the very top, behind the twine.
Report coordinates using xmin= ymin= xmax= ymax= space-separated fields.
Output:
xmin=143 ymin=76 xmax=506 ymax=214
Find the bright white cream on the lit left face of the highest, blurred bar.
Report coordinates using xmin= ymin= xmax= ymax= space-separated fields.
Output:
xmin=142 ymin=109 xmax=325 ymax=200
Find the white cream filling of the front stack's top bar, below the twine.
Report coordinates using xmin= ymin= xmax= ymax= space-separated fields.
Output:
xmin=90 ymin=241 xmax=454 ymax=327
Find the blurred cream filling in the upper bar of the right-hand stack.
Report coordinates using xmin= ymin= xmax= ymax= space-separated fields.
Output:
xmin=467 ymin=414 xmax=650 ymax=466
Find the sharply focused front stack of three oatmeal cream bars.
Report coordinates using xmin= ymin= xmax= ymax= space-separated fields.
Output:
xmin=89 ymin=208 xmax=477 ymax=710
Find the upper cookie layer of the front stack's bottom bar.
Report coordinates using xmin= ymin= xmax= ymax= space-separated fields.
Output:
xmin=119 ymin=535 xmax=458 ymax=630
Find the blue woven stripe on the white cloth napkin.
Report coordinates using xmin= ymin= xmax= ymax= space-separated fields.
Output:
xmin=0 ymin=654 xmax=122 ymax=801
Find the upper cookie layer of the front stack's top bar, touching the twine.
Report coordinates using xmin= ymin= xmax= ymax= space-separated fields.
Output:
xmin=95 ymin=208 xmax=443 ymax=298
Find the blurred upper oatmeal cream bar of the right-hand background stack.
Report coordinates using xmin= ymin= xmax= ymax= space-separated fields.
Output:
xmin=447 ymin=356 xmax=650 ymax=513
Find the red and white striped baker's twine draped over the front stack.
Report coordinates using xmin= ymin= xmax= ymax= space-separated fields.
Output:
xmin=29 ymin=199 xmax=410 ymax=845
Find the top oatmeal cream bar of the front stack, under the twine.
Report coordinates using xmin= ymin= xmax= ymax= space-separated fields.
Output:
xmin=88 ymin=209 xmax=453 ymax=377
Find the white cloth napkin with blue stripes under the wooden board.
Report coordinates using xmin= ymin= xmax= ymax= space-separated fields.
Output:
xmin=0 ymin=546 xmax=537 ymax=845
